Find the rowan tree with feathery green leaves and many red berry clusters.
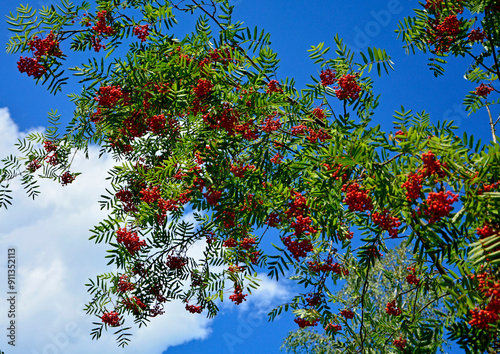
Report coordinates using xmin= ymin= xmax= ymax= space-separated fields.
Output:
xmin=0 ymin=0 xmax=500 ymax=352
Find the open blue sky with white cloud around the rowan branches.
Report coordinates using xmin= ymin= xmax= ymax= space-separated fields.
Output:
xmin=0 ymin=0 xmax=490 ymax=354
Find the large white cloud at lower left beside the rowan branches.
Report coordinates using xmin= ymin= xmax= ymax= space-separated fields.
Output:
xmin=0 ymin=108 xmax=211 ymax=354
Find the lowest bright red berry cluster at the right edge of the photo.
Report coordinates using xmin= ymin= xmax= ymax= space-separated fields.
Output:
xmin=469 ymin=273 xmax=500 ymax=329
